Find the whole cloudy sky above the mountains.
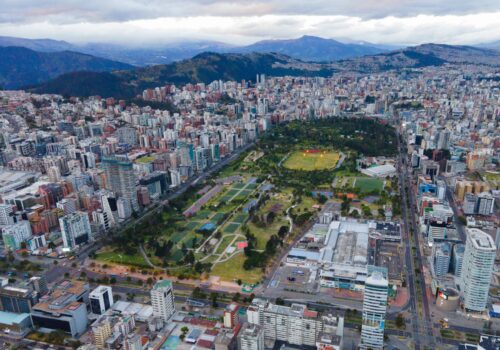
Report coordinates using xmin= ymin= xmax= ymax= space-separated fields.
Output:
xmin=0 ymin=0 xmax=500 ymax=47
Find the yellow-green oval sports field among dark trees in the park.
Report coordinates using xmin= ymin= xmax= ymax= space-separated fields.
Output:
xmin=283 ymin=150 xmax=340 ymax=171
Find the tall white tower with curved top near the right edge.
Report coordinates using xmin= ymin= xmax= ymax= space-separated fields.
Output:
xmin=460 ymin=228 xmax=496 ymax=312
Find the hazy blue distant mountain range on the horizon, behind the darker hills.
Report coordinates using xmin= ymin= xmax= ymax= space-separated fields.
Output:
xmin=0 ymin=35 xmax=389 ymax=66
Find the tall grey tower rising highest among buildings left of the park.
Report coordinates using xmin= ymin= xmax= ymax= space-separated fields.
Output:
xmin=101 ymin=157 xmax=139 ymax=211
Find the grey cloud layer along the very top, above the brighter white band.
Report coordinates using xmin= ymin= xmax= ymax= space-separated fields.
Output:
xmin=0 ymin=0 xmax=500 ymax=24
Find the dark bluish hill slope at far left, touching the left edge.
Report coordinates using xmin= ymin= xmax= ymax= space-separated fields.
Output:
xmin=0 ymin=46 xmax=132 ymax=89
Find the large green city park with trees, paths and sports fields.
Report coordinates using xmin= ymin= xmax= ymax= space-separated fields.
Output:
xmin=94 ymin=118 xmax=398 ymax=284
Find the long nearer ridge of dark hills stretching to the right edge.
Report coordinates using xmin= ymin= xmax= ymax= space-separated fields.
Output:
xmin=31 ymin=44 xmax=500 ymax=98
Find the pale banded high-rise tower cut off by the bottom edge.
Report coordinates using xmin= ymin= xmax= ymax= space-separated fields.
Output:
xmin=360 ymin=265 xmax=389 ymax=350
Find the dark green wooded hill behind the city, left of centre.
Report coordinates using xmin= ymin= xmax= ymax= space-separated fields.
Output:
xmin=32 ymin=52 xmax=333 ymax=98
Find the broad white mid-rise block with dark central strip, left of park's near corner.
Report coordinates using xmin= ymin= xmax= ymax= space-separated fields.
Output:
xmin=59 ymin=211 xmax=92 ymax=250
